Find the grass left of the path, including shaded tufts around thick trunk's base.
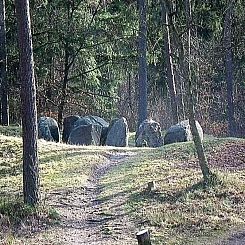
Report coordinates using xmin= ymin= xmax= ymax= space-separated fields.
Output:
xmin=0 ymin=127 xmax=114 ymax=240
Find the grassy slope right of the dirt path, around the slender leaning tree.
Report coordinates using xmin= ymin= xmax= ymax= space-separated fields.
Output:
xmin=102 ymin=139 xmax=245 ymax=244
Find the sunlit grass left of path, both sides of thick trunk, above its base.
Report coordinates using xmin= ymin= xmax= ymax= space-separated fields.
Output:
xmin=0 ymin=135 xmax=108 ymax=196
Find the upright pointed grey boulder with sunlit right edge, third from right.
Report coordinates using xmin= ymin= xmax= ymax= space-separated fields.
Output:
xmin=105 ymin=117 xmax=129 ymax=147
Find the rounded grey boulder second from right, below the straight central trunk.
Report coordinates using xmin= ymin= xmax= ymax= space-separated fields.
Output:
xmin=135 ymin=119 xmax=163 ymax=147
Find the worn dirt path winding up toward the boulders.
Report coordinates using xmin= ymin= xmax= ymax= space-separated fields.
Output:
xmin=17 ymin=153 xmax=137 ymax=245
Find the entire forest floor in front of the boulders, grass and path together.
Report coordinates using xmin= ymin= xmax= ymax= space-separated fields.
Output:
xmin=0 ymin=125 xmax=245 ymax=245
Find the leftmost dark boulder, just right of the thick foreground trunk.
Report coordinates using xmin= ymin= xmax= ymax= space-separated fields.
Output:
xmin=38 ymin=117 xmax=60 ymax=142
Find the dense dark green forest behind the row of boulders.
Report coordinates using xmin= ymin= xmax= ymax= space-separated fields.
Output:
xmin=0 ymin=0 xmax=245 ymax=136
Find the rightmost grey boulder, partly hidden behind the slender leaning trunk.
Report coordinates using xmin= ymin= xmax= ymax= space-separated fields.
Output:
xmin=164 ymin=120 xmax=203 ymax=145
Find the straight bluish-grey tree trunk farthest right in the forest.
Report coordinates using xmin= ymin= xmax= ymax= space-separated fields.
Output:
xmin=224 ymin=1 xmax=236 ymax=136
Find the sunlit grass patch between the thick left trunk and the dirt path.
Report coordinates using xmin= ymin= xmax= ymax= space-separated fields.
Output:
xmin=40 ymin=144 xmax=106 ymax=191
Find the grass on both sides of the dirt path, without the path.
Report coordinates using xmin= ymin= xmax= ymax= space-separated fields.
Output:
xmin=0 ymin=127 xmax=245 ymax=244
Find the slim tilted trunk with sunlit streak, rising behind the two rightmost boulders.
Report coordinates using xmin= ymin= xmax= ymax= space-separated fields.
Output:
xmin=161 ymin=0 xmax=179 ymax=124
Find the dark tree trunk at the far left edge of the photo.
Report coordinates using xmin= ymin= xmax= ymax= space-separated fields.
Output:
xmin=0 ymin=0 xmax=9 ymax=126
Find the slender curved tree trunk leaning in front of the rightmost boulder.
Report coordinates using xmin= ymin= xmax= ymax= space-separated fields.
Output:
xmin=185 ymin=0 xmax=212 ymax=183
